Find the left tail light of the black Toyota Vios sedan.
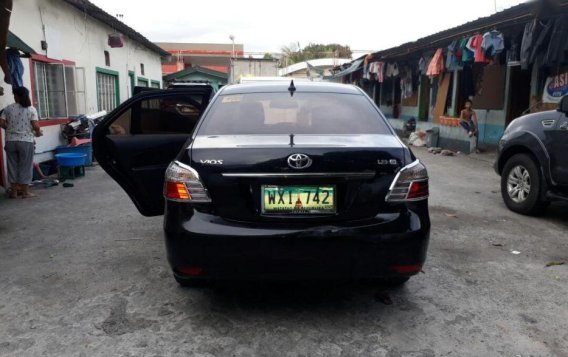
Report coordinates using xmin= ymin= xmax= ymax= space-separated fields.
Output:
xmin=164 ymin=161 xmax=211 ymax=203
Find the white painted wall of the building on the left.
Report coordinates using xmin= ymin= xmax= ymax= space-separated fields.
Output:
xmin=0 ymin=0 xmax=162 ymax=184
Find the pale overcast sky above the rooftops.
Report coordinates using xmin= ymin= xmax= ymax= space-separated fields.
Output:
xmin=91 ymin=0 xmax=526 ymax=57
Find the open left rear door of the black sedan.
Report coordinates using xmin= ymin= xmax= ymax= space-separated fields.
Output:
xmin=93 ymin=86 xmax=212 ymax=216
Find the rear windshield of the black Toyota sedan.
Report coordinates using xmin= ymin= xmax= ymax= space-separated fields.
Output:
xmin=199 ymin=92 xmax=389 ymax=135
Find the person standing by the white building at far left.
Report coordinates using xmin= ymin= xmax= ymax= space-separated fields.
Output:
xmin=0 ymin=87 xmax=43 ymax=198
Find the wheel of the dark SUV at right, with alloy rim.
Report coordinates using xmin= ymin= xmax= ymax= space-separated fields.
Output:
xmin=501 ymin=154 xmax=548 ymax=215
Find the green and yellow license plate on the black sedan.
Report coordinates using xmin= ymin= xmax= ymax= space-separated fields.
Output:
xmin=262 ymin=186 xmax=336 ymax=214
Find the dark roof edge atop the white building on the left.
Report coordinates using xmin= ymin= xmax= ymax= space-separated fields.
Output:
xmin=63 ymin=0 xmax=170 ymax=57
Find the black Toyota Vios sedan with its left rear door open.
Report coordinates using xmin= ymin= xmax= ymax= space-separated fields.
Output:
xmin=94 ymin=82 xmax=430 ymax=285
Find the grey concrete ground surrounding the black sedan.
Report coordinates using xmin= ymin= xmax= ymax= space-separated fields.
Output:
xmin=0 ymin=149 xmax=568 ymax=357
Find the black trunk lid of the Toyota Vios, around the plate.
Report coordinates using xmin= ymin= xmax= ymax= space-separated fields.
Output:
xmin=190 ymin=134 xmax=406 ymax=222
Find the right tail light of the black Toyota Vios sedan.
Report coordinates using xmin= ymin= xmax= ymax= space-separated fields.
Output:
xmin=386 ymin=160 xmax=429 ymax=202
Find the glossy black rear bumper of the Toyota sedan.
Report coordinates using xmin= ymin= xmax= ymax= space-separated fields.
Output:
xmin=164 ymin=202 xmax=430 ymax=280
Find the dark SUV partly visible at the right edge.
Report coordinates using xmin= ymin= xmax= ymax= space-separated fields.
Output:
xmin=495 ymin=96 xmax=568 ymax=215
